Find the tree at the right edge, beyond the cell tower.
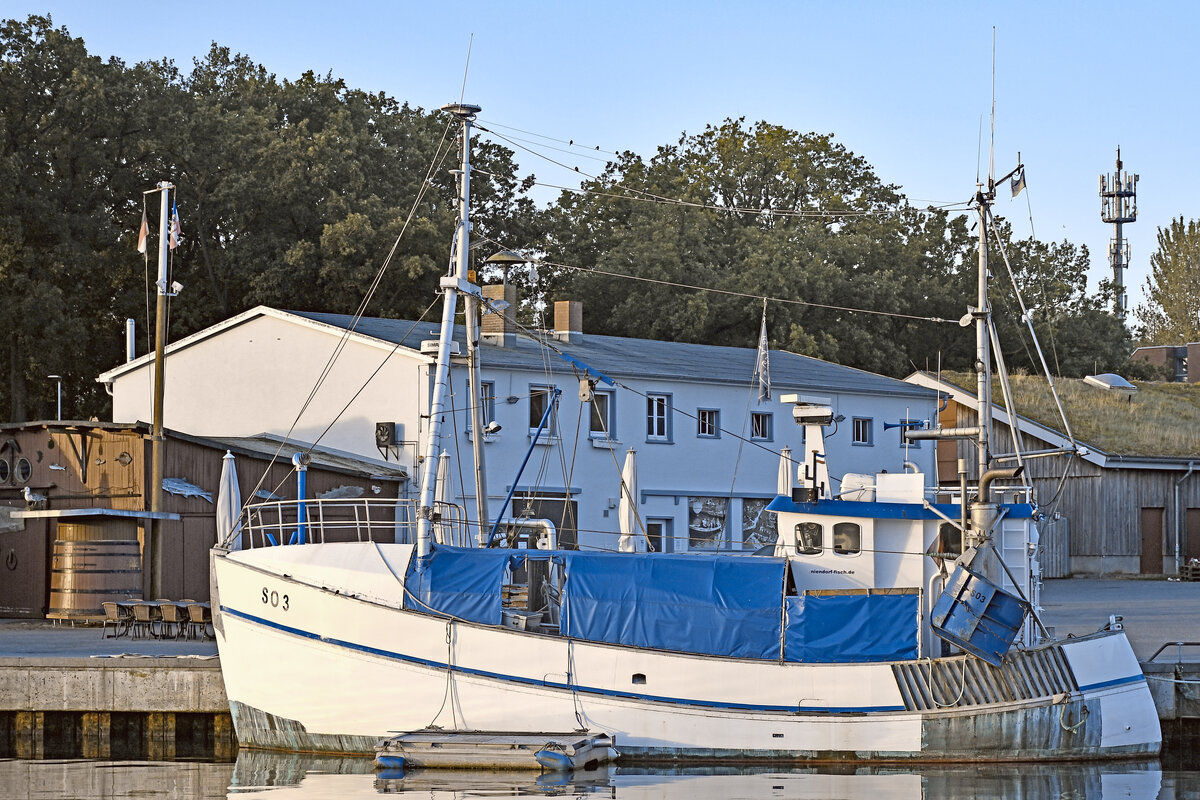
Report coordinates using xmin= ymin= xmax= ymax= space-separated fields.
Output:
xmin=1134 ymin=216 xmax=1200 ymax=344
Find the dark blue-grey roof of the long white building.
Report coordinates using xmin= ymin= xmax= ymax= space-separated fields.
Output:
xmin=287 ymin=311 xmax=935 ymax=397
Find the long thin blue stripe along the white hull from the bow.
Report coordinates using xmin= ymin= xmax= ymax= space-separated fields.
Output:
xmin=221 ymin=606 xmax=905 ymax=714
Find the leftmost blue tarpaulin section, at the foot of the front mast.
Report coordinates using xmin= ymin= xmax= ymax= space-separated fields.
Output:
xmin=404 ymin=547 xmax=512 ymax=625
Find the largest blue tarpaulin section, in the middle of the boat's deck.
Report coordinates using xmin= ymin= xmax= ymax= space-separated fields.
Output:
xmin=563 ymin=553 xmax=786 ymax=658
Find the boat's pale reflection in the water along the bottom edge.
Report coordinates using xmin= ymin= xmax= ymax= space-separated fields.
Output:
xmin=229 ymin=752 xmax=1180 ymax=800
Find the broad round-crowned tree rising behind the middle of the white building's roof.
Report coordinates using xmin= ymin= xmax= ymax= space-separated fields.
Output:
xmin=546 ymin=120 xmax=971 ymax=374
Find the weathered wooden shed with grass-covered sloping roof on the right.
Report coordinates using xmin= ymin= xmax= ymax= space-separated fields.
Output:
xmin=907 ymin=373 xmax=1200 ymax=578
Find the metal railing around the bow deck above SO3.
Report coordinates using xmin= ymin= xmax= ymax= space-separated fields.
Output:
xmin=241 ymin=498 xmax=472 ymax=549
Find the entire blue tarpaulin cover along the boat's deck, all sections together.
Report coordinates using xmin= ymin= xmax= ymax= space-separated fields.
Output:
xmin=406 ymin=546 xmax=918 ymax=663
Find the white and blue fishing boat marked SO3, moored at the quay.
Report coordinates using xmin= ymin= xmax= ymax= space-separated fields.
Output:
xmin=211 ymin=104 xmax=1160 ymax=763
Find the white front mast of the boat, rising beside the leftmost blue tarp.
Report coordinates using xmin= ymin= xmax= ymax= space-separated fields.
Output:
xmin=416 ymin=103 xmax=482 ymax=558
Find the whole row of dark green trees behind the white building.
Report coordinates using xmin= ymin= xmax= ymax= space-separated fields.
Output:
xmin=0 ymin=17 xmax=1132 ymax=421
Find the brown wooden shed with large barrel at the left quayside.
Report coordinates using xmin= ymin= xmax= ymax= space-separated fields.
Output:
xmin=0 ymin=421 xmax=407 ymax=619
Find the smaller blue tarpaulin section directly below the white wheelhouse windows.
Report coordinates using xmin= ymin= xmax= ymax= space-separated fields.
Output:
xmin=784 ymin=593 xmax=918 ymax=663
